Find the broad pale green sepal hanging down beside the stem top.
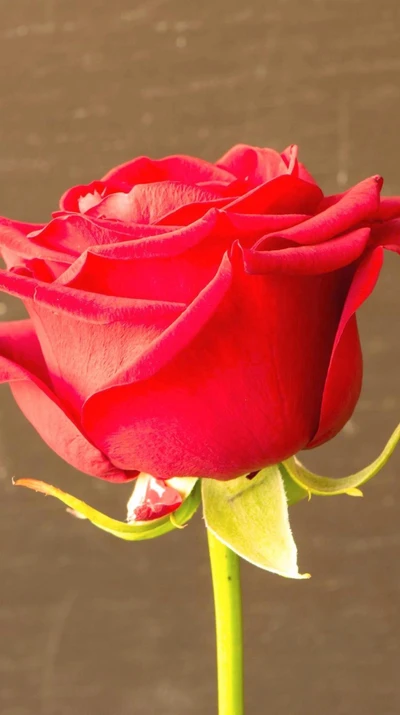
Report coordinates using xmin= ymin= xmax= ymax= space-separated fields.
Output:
xmin=201 ymin=466 xmax=308 ymax=578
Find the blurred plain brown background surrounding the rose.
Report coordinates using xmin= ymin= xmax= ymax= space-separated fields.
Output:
xmin=0 ymin=0 xmax=400 ymax=715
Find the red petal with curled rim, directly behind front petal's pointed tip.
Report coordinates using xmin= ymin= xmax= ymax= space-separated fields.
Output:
xmin=59 ymin=210 xmax=312 ymax=303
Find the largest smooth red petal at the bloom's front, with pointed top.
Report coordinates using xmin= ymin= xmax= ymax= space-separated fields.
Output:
xmin=83 ymin=254 xmax=348 ymax=479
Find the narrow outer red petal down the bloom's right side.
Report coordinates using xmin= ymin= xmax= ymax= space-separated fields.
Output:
xmin=308 ymin=248 xmax=383 ymax=448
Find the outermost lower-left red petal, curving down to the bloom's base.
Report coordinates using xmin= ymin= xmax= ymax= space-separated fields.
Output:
xmin=0 ymin=320 xmax=136 ymax=482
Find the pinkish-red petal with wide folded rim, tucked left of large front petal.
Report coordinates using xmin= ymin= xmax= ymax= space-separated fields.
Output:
xmin=0 ymin=271 xmax=184 ymax=412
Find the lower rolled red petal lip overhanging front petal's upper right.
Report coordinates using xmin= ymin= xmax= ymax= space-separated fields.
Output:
xmin=243 ymin=228 xmax=371 ymax=275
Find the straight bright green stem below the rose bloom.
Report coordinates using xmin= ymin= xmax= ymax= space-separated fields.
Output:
xmin=207 ymin=530 xmax=243 ymax=715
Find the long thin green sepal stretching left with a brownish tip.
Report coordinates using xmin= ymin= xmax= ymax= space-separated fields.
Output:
xmin=14 ymin=479 xmax=201 ymax=541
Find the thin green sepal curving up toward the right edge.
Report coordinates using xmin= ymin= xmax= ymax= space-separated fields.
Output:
xmin=283 ymin=425 xmax=400 ymax=496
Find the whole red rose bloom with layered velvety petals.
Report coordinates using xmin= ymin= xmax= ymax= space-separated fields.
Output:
xmin=0 ymin=146 xmax=400 ymax=480
